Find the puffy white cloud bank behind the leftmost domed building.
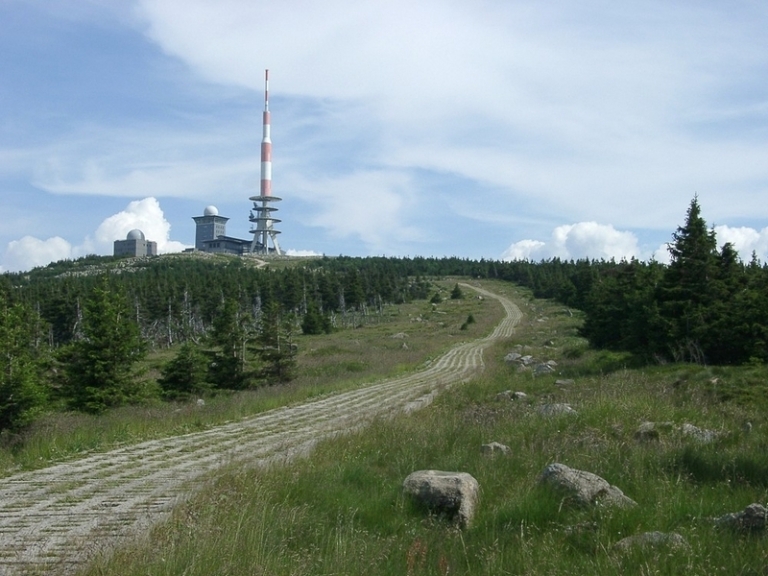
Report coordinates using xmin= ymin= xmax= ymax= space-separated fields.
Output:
xmin=0 ymin=198 xmax=187 ymax=272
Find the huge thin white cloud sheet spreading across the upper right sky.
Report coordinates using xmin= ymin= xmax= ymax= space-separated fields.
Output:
xmin=134 ymin=0 xmax=768 ymax=234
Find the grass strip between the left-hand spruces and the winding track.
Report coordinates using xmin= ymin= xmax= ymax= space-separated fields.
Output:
xmin=0 ymin=280 xmax=501 ymax=476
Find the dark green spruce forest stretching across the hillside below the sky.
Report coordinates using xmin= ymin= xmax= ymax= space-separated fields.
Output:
xmin=0 ymin=198 xmax=768 ymax=431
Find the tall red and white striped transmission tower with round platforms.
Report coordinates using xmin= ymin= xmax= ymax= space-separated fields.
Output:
xmin=249 ymin=70 xmax=282 ymax=254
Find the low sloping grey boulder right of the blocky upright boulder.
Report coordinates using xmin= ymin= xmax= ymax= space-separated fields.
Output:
xmin=539 ymin=463 xmax=637 ymax=508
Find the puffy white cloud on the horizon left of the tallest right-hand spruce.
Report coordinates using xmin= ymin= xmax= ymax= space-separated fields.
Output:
xmin=502 ymin=222 xmax=640 ymax=261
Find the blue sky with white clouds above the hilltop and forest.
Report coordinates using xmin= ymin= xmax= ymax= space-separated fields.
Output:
xmin=0 ymin=0 xmax=768 ymax=272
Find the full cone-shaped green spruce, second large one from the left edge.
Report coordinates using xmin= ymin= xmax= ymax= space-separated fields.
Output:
xmin=59 ymin=276 xmax=146 ymax=412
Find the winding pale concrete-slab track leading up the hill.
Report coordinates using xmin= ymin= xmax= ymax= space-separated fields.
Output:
xmin=0 ymin=284 xmax=521 ymax=576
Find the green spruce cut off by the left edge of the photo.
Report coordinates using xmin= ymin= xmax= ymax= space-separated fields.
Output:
xmin=0 ymin=295 xmax=47 ymax=432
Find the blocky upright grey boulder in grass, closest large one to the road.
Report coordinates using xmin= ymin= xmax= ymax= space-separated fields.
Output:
xmin=403 ymin=470 xmax=480 ymax=528
